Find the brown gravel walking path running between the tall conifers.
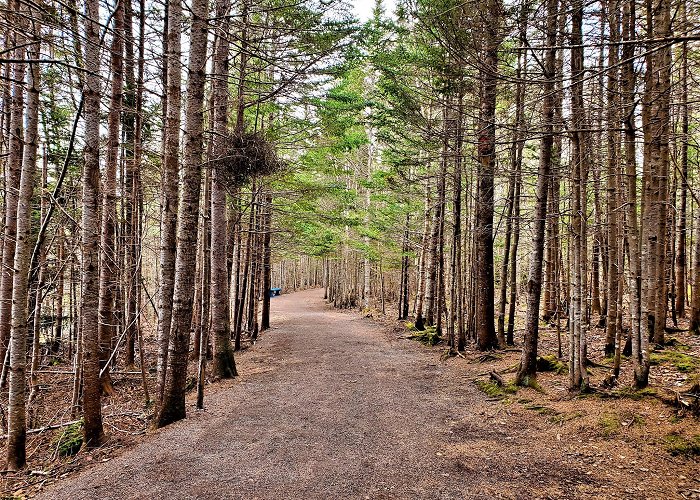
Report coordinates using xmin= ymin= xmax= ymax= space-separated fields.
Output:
xmin=44 ymin=290 xmax=577 ymax=499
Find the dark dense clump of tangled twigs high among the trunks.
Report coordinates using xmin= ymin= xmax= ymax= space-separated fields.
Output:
xmin=209 ymin=132 xmax=284 ymax=189
